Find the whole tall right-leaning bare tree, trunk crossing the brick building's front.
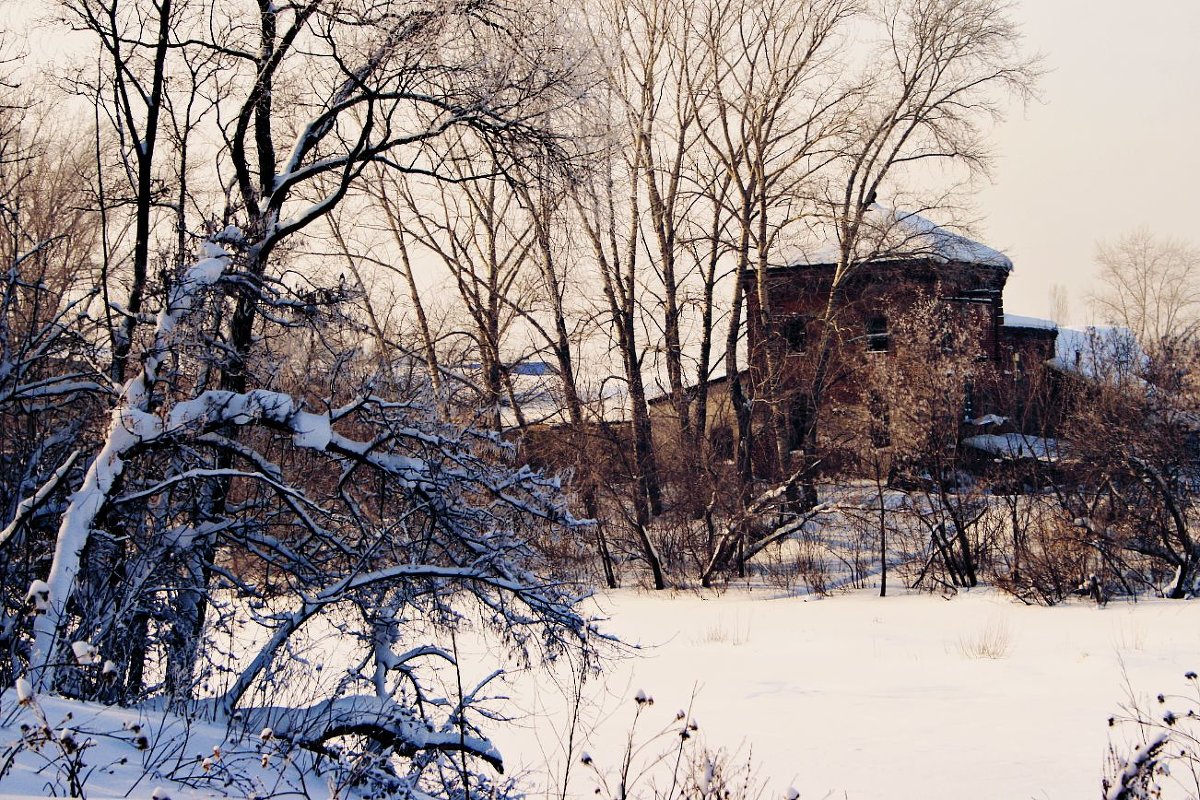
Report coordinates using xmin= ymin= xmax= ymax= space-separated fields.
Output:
xmin=748 ymin=0 xmax=1038 ymax=503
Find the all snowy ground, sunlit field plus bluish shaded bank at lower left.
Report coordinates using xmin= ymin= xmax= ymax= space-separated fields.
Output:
xmin=9 ymin=588 xmax=1200 ymax=800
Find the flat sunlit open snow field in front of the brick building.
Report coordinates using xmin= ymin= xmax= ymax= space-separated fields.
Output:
xmin=487 ymin=590 xmax=1200 ymax=800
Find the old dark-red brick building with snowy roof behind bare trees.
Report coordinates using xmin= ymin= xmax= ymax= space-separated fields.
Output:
xmin=744 ymin=206 xmax=1057 ymax=473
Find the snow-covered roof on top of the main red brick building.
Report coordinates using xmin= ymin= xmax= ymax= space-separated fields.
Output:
xmin=786 ymin=204 xmax=1013 ymax=271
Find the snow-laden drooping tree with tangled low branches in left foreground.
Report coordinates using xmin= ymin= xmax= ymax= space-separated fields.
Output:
xmin=0 ymin=230 xmax=593 ymax=794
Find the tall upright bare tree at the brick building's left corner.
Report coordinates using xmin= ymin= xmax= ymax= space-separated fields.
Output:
xmin=691 ymin=0 xmax=857 ymax=489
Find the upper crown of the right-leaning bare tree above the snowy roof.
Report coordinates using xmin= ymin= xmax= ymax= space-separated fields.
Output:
xmin=826 ymin=0 xmax=1039 ymax=302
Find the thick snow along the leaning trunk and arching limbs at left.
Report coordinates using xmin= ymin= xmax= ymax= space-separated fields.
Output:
xmin=35 ymin=230 xmax=582 ymax=695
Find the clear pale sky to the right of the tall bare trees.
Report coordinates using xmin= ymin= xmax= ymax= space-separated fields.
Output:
xmin=977 ymin=0 xmax=1200 ymax=324
